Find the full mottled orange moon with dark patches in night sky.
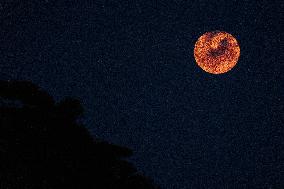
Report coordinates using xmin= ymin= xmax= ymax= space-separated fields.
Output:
xmin=194 ymin=31 xmax=240 ymax=74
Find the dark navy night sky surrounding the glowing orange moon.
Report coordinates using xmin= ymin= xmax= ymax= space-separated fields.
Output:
xmin=0 ymin=0 xmax=284 ymax=189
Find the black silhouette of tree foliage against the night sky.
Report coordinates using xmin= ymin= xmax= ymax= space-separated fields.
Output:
xmin=0 ymin=81 xmax=158 ymax=189
